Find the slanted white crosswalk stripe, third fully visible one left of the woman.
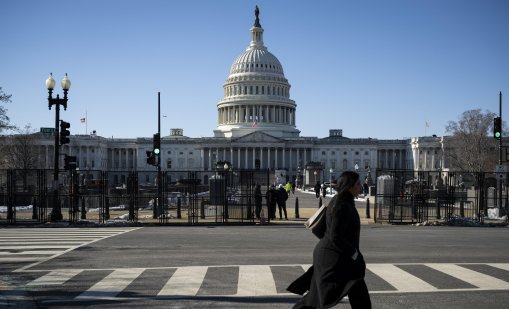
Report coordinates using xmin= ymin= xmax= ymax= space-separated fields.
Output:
xmin=76 ymin=268 xmax=145 ymax=299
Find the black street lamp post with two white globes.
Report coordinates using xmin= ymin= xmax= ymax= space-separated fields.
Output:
xmin=46 ymin=73 xmax=71 ymax=221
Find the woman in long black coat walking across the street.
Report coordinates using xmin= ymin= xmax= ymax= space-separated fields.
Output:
xmin=288 ymin=171 xmax=371 ymax=309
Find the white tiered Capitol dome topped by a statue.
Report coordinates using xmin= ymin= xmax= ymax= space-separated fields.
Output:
xmin=214 ymin=7 xmax=300 ymax=137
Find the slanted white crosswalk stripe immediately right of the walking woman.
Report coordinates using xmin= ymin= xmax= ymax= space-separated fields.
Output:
xmin=367 ymin=264 xmax=437 ymax=292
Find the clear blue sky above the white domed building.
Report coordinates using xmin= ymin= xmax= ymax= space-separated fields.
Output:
xmin=0 ymin=0 xmax=509 ymax=139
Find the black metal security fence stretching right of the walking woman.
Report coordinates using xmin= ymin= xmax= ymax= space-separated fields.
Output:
xmin=374 ymin=170 xmax=509 ymax=223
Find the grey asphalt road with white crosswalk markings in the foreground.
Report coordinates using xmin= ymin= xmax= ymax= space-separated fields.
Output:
xmin=0 ymin=224 xmax=509 ymax=309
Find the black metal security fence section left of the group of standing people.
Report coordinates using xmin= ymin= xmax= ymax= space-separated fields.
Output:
xmin=0 ymin=169 xmax=270 ymax=224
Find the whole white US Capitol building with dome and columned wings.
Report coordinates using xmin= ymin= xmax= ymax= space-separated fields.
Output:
xmin=19 ymin=9 xmax=443 ymax=185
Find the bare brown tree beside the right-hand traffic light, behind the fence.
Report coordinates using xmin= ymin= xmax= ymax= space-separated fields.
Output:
xmin=445 ymin=109 xmax=498 ymax=172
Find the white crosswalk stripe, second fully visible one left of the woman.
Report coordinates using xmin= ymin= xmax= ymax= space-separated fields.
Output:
xmin=157 ymin=266 xmax=208 ymax=296
